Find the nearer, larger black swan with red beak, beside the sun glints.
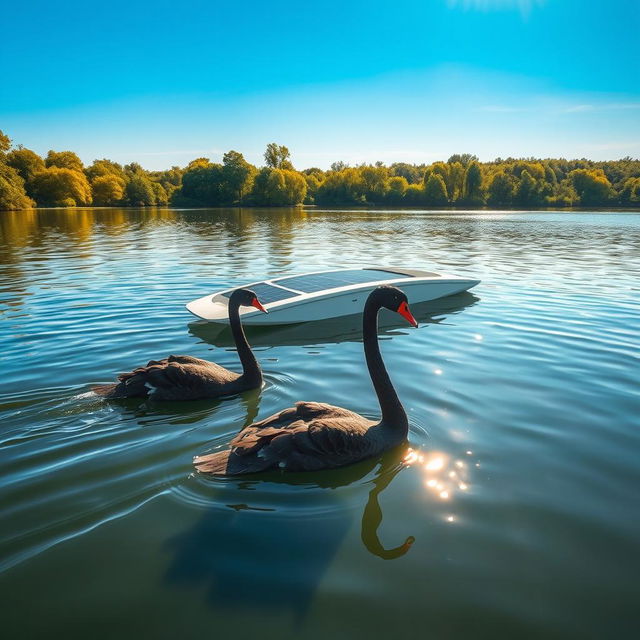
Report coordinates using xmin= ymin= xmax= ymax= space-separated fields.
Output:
xmin=194 ymin=286 xmax=418 ymax=476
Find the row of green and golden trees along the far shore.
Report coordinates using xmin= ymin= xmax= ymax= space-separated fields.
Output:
xmin=0 ymin=131 xmax=640 ymax=210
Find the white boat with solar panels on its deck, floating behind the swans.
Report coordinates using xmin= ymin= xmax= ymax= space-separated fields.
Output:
xmin=186 ymin=267 xmax=480 ymax=325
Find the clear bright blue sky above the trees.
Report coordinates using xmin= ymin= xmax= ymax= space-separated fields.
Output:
xmin=0 ymin=0 xmax=640 ymax=169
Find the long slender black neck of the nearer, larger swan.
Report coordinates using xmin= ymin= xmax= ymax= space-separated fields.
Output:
xmin=362 ymin=299 xmax=409 ymax=435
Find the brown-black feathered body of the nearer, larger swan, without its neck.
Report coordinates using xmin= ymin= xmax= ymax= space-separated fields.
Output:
xmin=194 ymin=402 xmax=385 ymax=475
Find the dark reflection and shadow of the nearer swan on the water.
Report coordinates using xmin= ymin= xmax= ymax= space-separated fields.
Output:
xmin=165 ymin=445 xmax=414 ymax=622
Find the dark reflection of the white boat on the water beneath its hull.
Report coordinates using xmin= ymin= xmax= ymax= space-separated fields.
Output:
xmin=189 ymin=291 xmax=479 ymax=347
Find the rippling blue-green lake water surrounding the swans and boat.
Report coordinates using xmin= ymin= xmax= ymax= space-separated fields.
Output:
xmin=0 ymin=209 xmax=640 ymax=640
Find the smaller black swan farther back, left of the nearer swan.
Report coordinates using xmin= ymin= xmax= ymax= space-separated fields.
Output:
xmin=93 ymin=289 xmax=267 ymax=400
